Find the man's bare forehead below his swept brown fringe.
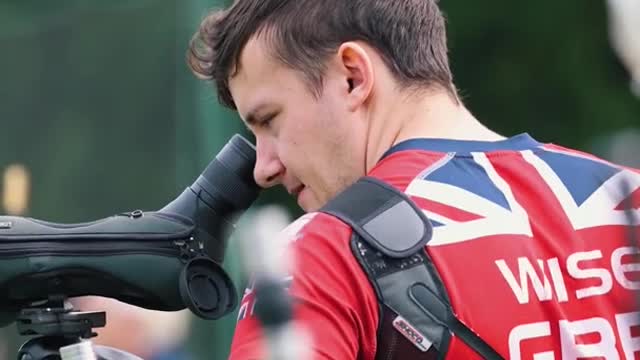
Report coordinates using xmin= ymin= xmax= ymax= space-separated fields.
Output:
xmin=229 ymin=37 xmax=305 ymax=115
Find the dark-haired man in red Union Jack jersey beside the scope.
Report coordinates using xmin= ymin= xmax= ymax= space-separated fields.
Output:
xmin=189 ymin=0 xmax=640 ymax=359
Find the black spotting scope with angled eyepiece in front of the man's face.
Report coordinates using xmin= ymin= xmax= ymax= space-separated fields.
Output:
xmin=0 ymin=135 xmax=260 ymax=326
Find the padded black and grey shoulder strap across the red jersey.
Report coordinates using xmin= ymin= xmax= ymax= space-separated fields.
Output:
xmin=320 ymin=177 xmax=502 ymax=360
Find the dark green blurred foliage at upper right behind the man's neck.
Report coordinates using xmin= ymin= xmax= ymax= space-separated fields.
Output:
xmin=441 ymin=0 xmax=640 ymax=150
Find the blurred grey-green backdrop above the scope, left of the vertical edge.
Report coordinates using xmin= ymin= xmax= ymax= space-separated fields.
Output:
xmin=0 ymin=0 xmax=177 ymax=359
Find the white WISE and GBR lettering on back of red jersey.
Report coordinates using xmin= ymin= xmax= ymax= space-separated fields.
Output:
xmin=495 ymin=246 xmax=640 ymax=360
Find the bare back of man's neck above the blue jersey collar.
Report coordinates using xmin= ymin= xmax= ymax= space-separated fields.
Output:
xmin=365 ymin=88 xmax=504 ymax=173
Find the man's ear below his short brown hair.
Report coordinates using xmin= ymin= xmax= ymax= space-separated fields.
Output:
xmin=337 ymin=41 xmax=374 ymax=110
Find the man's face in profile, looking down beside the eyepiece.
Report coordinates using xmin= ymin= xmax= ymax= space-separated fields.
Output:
xmin=229 ymin=38 xmax=367 ymax=211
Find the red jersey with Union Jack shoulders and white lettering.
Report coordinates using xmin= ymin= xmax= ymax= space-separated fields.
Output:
xmin=231 ymin=134 xmax=640 ymax=360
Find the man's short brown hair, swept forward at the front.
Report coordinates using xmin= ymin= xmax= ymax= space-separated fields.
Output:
xmin=187 ymin=0 xmax=457 ymax=109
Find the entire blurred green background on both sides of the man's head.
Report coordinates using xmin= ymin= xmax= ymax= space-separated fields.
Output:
xmin=0 ymin=0 xmax=640 ymax=360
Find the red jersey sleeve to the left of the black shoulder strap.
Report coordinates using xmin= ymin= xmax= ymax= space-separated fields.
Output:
xmin=231 ymin=214 xmax=378 ymax=359
